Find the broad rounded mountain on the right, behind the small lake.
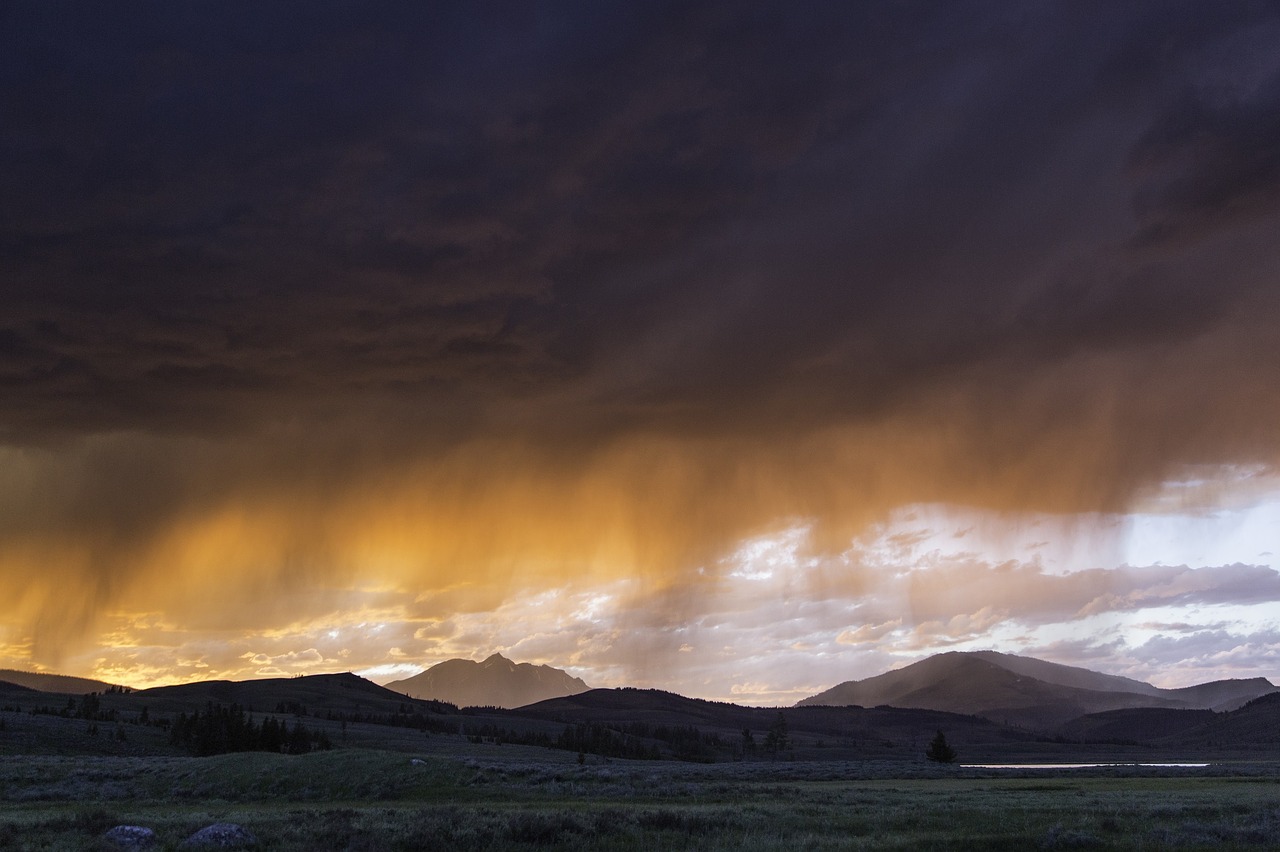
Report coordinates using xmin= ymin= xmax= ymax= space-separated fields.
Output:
xmin=797 ymin=651 xmax=1276 ymax=729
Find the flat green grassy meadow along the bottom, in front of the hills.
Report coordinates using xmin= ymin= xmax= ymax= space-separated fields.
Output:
xmin=0 ymin=750 xmax=1280 ymax=851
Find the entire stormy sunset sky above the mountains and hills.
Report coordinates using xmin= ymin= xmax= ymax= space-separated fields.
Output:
xmin=0 ymin=0 xmax=1280 ymax=705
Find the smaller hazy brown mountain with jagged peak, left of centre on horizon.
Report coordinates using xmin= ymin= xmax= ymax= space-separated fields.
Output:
xmin=387 ymin=654 xmax=589 ymax=707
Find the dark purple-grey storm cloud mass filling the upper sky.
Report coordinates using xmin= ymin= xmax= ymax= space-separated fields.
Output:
xmin=0 ymin=4 xmax=1280 ymax=441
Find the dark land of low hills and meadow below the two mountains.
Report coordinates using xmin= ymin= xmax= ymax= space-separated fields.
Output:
xmin=0 ymin=674 xmax=1280 ymax=851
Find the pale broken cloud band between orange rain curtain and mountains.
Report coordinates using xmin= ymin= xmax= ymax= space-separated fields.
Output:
xmin=37 ymin=516 xmax=1280 ymax=704
